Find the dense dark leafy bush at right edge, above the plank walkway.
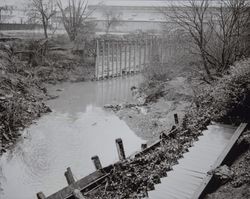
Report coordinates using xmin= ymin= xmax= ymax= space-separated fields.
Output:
xmin=196 ymin=59 xmax=250 ymax=123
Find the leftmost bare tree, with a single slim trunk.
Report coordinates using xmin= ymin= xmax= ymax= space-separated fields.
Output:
xmin=28 ymin=0 xmax=56 ymax=38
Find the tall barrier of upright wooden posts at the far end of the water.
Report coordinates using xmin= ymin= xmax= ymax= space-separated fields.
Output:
xmin=95 ymin=36 xmax=181 ymax=80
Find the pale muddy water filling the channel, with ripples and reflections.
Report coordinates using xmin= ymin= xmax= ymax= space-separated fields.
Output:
xmin=0 ymin=76 xmax=143 ymax=199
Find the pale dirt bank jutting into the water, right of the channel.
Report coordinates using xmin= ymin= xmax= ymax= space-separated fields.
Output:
xmin=107 ymin=77 xmax=192 ymax=143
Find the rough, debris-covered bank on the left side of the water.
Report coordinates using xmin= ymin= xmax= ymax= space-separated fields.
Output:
xmin=0 ymin=35 xmax=94 ymax=154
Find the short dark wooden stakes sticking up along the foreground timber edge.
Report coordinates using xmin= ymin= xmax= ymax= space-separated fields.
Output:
xmin=37 ymin=114 xmax=179 ymax=199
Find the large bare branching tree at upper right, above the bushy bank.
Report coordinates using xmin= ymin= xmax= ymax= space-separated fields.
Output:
xmin=163 ymin=0 xmax=250 ymax=79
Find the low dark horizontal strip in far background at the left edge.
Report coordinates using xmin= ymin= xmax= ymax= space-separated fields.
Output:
xmin=0 ymin=23 xmax=43 ymax=30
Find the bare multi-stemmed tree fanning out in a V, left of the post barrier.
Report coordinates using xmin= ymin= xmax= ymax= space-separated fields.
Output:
xmin=57 ymin=0 xmax=93 ymax=41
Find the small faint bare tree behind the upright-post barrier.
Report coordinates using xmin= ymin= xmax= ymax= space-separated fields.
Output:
xmin=102 ymin=5 xmax=122 ymax=34
